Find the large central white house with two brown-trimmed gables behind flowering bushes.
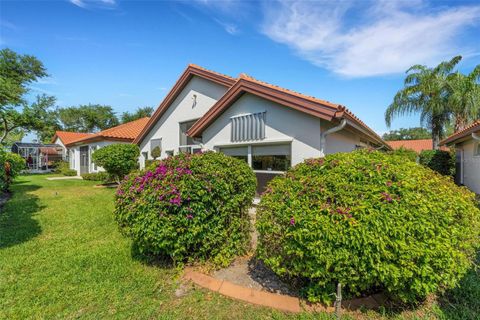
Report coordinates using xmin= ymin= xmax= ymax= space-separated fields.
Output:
xmin=134 ymin=64 xmax=391 ymax=191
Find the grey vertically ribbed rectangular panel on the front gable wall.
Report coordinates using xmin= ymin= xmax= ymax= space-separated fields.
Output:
xmin=230 ymin=112 xmax=266 ymax=142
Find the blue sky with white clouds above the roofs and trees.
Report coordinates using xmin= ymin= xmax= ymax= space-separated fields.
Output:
xmin=0 ymin=0 xmax=480 ymax=138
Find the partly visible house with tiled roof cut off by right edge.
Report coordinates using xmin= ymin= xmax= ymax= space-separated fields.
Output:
xmin=440 ymin=120 xmax=480 ymax=194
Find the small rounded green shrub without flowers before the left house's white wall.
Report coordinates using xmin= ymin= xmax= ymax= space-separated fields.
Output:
xmin=92 ymin=144 xmax=140 ymax=182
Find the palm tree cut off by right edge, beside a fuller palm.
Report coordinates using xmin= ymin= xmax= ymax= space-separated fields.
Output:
xmin=447 ymin=65 xmax=480 ymax=132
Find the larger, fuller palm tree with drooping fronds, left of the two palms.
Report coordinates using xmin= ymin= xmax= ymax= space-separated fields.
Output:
xmin=385 ymin=56 xmax=462 ymax=149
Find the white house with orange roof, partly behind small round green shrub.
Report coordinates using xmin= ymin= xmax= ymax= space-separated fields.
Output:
xmin=65 ymin=118 xmax=149 ymax=175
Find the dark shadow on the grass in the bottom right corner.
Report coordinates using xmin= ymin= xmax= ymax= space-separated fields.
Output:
xmin=439 ymin=252 xmax=480 ymax=320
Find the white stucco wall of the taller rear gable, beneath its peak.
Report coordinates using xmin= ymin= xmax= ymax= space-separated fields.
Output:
xmin=139 ymin=76 xmax=227 ymax=168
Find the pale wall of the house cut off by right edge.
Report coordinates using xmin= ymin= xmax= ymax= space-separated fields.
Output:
xmin=455 ymin=139 xmax=480 ymax=194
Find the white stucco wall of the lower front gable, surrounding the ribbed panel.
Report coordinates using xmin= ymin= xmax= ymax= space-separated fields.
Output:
xmin=202 ymin=94 xmax=360 ymax=166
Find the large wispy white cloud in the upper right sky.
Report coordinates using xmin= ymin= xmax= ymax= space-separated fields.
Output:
xmin=262 ymin=0 xmax=480 ymax=77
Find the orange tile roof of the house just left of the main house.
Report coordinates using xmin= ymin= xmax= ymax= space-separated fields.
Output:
xmin=64 ymin=117 xmax=150 ymax=145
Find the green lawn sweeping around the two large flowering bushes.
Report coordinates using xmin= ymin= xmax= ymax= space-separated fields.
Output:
xmin=0 ymin=175 xmax=480 ymax=319
